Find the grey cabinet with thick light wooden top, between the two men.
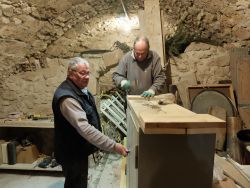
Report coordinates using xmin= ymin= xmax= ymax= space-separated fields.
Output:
xmin=127 ymin=96 xmax=225 ymax=188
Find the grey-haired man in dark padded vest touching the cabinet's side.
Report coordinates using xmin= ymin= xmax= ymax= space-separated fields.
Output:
xmin=52 ymin=57 xmax=127 ymax=188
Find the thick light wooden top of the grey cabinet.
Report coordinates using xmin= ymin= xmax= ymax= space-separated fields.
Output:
xmin=127 ymin=95 xmax=226 ymax=134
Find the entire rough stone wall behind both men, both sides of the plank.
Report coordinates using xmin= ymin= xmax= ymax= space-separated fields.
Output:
xmin=0 ymin=0 xmax=250 ymax=117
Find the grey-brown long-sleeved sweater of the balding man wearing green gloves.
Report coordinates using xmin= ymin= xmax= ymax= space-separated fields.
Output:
xmin=113 ymin=50 xmax=166 ymax=95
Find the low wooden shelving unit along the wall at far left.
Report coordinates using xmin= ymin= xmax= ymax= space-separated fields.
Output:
xmin=0 ymin=120 xmax=61 ymax=171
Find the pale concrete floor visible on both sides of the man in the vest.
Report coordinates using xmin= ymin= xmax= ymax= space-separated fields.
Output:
xmin=0 ymin=154 xmax=122 ymax=188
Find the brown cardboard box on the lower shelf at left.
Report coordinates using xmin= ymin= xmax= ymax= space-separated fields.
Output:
xmin=16 ymin=145 xmax=39 ymax=164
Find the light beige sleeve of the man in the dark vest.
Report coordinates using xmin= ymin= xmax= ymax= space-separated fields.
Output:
xmin=60 ymin=98 xmax=116 ymax=152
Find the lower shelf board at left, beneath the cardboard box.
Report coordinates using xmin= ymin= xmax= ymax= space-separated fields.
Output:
xmin=0 ymin=160 xmax=62 ymax=172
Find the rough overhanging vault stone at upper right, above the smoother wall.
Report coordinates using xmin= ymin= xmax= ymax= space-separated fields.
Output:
xmin=161 ymin=0 xmax=250 ymax=47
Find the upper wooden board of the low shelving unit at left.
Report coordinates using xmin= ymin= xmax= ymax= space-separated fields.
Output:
xmin=0 ymin=120 xmax=54 ymax=128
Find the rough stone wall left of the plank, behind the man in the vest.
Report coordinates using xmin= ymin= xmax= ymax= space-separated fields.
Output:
xmin=0 ymin=0 xmax=140 ymax=117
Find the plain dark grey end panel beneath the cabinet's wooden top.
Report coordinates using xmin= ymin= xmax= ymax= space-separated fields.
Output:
xmin=138 ymin=134 xmax=215 ymax=188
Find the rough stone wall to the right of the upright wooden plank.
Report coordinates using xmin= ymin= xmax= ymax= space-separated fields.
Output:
xmin=161 ymin=0 xmax=250 ymax=84
